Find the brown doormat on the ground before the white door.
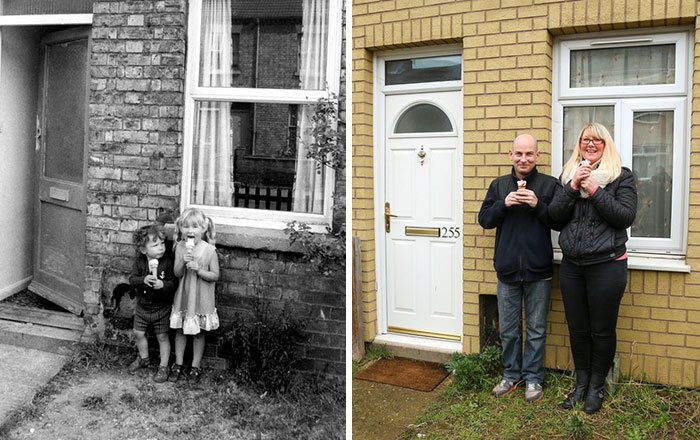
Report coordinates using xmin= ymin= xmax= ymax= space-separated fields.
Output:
xmin=354 ymin=357 xmax=447 ymax=391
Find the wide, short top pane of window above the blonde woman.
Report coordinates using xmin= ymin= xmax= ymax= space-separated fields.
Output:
xmin=570 ymin=44 xmax=676 ymax=88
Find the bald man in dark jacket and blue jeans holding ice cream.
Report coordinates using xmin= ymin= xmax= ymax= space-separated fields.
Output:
xmin=479 ymin=134 xmax=558 ymax=402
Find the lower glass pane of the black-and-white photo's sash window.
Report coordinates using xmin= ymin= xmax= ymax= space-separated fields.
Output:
xmin=190 ymin=102 xmax=325 ymax=214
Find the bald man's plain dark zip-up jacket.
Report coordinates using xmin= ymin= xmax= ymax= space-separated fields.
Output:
xmin=479 ymin=168 xmax=559 ymax=283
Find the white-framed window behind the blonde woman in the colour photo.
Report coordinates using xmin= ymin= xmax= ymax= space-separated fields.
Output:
xmin=552 ymin=31 xmax=692 ymax=255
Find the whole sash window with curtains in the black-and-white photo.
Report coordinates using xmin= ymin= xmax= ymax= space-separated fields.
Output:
xmin=182 ymin=0 xmax=341 ymax=230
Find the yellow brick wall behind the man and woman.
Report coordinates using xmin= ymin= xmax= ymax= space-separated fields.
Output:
xmin=352 ymin=0 xmax=700 ymax=387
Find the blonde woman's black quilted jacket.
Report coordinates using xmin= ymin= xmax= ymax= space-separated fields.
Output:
xmin=549 ymin=167 xmax=637 ymax=266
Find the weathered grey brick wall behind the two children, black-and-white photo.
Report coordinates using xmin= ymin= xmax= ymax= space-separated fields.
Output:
xmin=85 ymin=0 xmax=345 ymax=376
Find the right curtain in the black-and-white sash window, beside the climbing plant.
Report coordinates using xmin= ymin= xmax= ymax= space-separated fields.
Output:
xmin=292 ymin=0 xmax=329 ymax=214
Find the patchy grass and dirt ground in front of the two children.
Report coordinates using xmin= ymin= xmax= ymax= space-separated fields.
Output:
xmin=4 ymin=371 xmax=345 ymax=440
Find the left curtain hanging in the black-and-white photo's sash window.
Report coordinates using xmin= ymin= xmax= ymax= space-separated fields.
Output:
xmin=192 ymin=0 xmax=233 ymax=206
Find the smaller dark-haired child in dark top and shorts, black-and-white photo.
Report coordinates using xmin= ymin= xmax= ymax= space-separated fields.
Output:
xmin=129 ymin=225 xmax=178 ymax=382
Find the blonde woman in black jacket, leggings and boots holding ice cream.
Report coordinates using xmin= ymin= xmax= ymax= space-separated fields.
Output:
xmin=549 ymin=122 xmax=637 ymax=414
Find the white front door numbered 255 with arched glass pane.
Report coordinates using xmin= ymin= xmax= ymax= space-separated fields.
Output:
xmin=378 ymin=90 xmax=463 ymax=340
